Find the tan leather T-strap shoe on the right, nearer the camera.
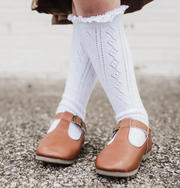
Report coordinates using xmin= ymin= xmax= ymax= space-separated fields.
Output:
xmin=95 ymin=119 xmax=152 ymax=177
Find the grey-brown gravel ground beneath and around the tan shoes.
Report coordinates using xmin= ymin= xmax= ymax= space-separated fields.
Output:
xmin=0 ymin=76 xmax=180 ymax=188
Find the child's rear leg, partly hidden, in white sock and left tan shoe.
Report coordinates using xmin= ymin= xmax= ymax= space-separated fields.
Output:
xmin=36 ymin=6 xmax=96 ymax=164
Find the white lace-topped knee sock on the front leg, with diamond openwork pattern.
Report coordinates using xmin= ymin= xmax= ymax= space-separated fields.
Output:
xmin=68 ymin=6 xmax=148 ymax=146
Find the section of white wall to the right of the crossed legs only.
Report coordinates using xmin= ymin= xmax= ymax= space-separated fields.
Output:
xmin=124 ymin=0 xmax=180 ymax=75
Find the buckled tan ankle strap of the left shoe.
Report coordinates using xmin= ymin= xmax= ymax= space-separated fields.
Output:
xmin=53 ymin=112 xmax=87 ymax=135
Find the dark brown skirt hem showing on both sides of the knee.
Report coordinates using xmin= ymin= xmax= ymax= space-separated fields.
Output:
xmin=31 ymin=0 xmax=153 ymax=24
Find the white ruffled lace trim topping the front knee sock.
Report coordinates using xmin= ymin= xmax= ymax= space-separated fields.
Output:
xmin=68 ymin=5 xmax=129 ymax=23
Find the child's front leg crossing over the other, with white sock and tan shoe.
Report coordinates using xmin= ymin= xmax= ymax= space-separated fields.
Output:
xmin=69 ymin=0 xmax=152 ymax=177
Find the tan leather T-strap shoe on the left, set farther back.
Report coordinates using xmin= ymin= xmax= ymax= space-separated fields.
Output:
xmin=36 ymin=112 xmax=87 ymax=164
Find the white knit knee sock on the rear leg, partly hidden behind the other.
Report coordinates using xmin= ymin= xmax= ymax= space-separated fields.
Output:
xmin=48 ymin=23 xmax=96 ymax=137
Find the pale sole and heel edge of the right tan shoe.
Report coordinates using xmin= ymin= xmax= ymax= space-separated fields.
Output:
xmin=96 ymin=151 xmax=151 ymax=178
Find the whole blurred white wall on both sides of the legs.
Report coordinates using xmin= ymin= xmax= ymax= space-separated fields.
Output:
xmin=0 ymin=0 xmax=180 ymax=78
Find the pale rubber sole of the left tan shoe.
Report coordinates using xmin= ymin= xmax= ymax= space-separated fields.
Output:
xmin=36 ymin=155 xmax=75 ymax=165
